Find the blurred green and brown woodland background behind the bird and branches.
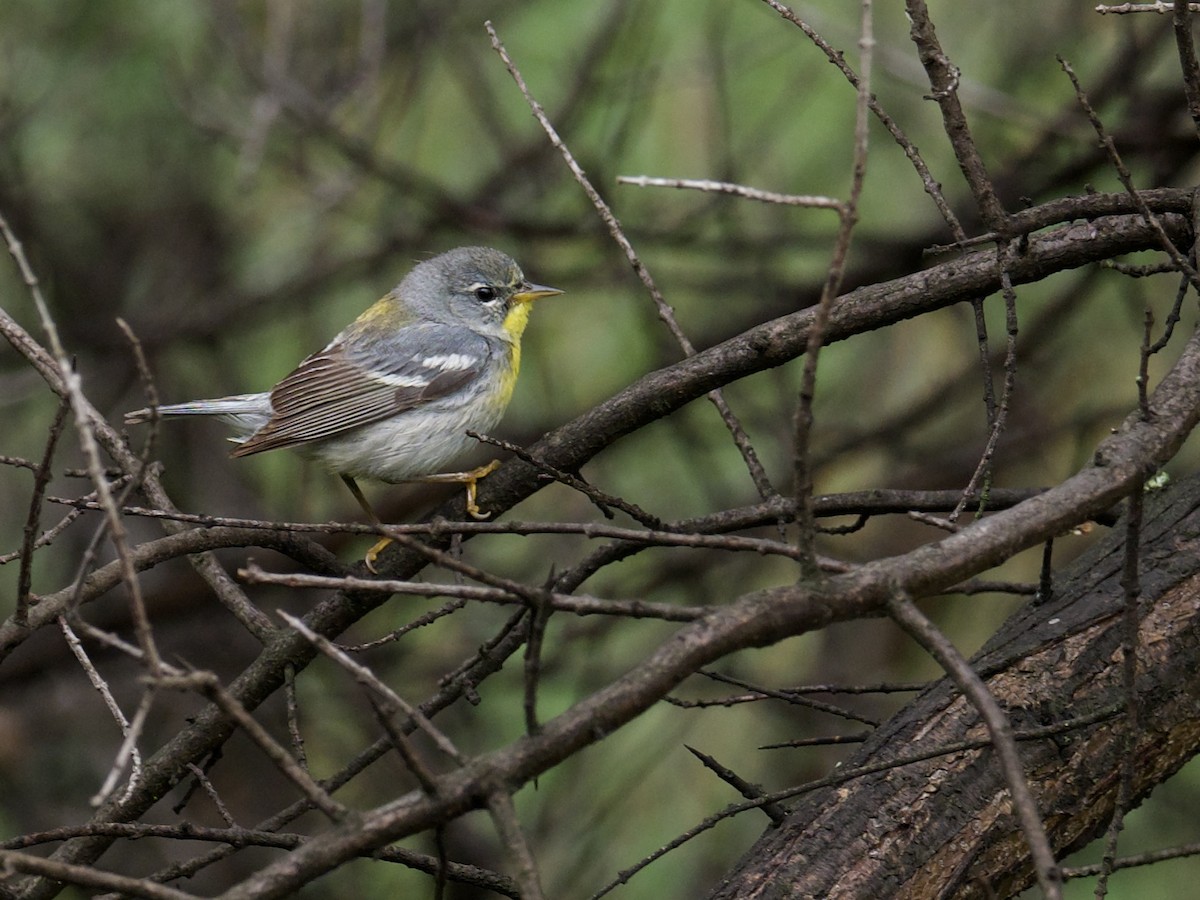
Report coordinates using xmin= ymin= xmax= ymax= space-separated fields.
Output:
xmin=0 ymin=0 xmax=1200 ymax=898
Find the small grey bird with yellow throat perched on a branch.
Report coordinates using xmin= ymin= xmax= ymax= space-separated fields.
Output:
xmin=125 ymin=247 xmax=563 ymax=570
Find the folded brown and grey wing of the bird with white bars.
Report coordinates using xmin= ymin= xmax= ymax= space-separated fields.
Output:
xmin=233 ymin=324 xmax=490 ymax=456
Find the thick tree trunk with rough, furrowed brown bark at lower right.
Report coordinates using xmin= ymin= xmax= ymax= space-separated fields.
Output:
xmin=713 ymin=478 xmax=1200 ymax=900
